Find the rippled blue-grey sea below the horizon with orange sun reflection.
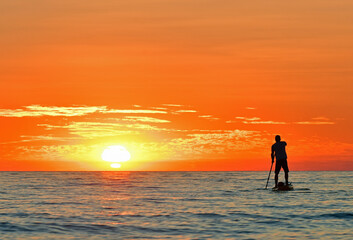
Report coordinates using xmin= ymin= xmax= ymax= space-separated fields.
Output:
xmin=0 ymin=172 xmax=353 ymax=239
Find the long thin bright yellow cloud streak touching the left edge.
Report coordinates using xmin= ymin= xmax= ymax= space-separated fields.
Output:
xmin=0 ymin=105 xmax=107 ymax=117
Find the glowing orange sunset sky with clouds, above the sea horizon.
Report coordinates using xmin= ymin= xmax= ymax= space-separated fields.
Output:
xmin=0 ymin=0 xmax=353 ymax=171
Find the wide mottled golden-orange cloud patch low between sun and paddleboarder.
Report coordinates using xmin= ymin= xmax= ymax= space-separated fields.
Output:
xmin=114 ymin=129 xmax=267 ymax=160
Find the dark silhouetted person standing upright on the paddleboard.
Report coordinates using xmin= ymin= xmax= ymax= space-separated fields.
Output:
xmin=271 ymin=135 xmax=289 ymax=187
